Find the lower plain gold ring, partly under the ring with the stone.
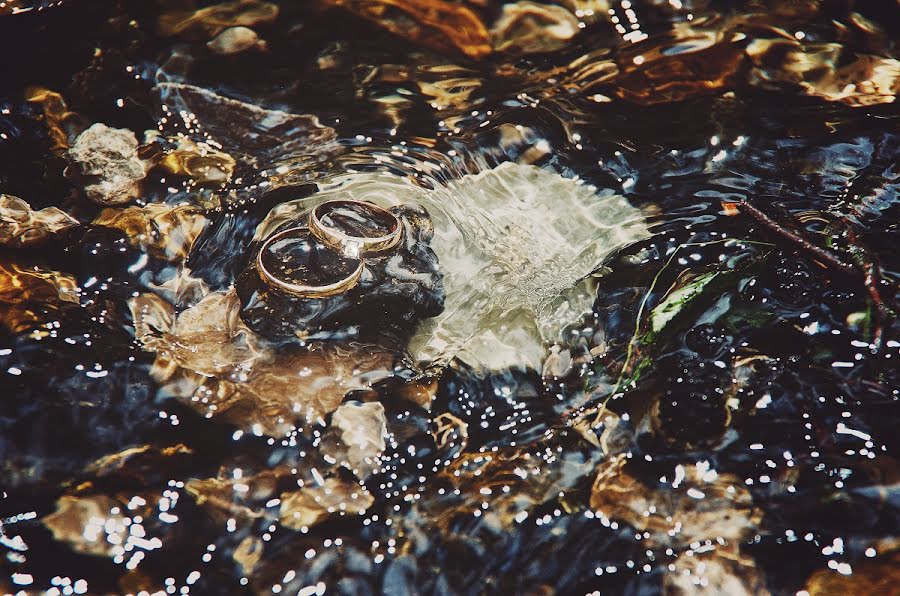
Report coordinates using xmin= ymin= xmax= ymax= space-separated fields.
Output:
xmin=256 ymin=226 xmax=365 ymax=298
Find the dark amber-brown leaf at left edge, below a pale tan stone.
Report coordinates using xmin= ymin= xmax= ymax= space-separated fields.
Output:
xmin=0 ymin=260 xmax=79 ymax=333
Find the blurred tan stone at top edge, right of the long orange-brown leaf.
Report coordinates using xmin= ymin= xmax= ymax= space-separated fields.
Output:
xmin=491 ymin=0 xmax=581 ymax=54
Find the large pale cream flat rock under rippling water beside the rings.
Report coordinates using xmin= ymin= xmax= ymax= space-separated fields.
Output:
xmin=276 ymin=162 xmax=648 ymax=370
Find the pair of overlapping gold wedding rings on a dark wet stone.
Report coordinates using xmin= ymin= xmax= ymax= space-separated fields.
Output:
xmin=256 ymin=199 xmax=403 ymax=298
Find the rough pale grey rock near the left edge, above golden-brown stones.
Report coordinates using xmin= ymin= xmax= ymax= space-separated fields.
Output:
xmin=68 ymin=122 xmax=146 ymax=205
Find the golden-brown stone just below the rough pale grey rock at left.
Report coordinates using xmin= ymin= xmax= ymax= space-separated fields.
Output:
xmin=93 ymin=203 xmax=208 ymax=261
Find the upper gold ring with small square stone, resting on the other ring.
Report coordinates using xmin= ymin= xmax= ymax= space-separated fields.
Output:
xmin=309 ymin=199 xmax=403 ymax=257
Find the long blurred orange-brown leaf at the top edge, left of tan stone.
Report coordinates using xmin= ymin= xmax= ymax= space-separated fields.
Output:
xmin=331 ymin=0 xmax=491 ymax=60
